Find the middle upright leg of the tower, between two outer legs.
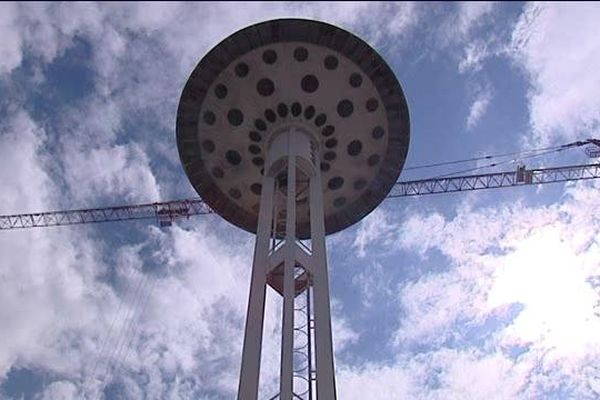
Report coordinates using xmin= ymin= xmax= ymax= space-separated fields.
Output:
xmin=279 ymin=128 xmax=296 ymax=400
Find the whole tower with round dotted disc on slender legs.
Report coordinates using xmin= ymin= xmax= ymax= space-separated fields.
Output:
xmin=177 ymin=19 xmax=409 ymax=400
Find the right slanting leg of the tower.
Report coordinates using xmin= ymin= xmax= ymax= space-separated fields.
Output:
xmin=310 ymin=168 xmax=336 ymax=400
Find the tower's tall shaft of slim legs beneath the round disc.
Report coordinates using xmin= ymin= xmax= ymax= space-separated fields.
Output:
xmin=238 ymin=126 xmax=336 ymax=400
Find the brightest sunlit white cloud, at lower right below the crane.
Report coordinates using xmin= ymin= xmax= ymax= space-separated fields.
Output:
xmin=386 ymin=180 xmax=600 ymax=398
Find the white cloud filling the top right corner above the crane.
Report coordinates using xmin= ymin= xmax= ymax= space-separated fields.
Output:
xmin=512 ymin=3 xmax=600 ymax=144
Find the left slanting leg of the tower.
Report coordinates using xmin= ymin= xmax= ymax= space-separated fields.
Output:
xmin=238 ymin=172 xmax=275 ymax=400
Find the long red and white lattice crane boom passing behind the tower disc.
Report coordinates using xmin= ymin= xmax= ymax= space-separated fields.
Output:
xmin=0 ymin=163 xmax=600 ymax=230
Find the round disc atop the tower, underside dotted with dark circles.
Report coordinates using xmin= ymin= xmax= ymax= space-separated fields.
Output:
xmin=177 ymin=19 xmax=410 ymax=239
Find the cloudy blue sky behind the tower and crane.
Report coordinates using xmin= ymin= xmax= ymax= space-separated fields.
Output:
xmin=0 ymin=2 xmax=600 ymax=400
